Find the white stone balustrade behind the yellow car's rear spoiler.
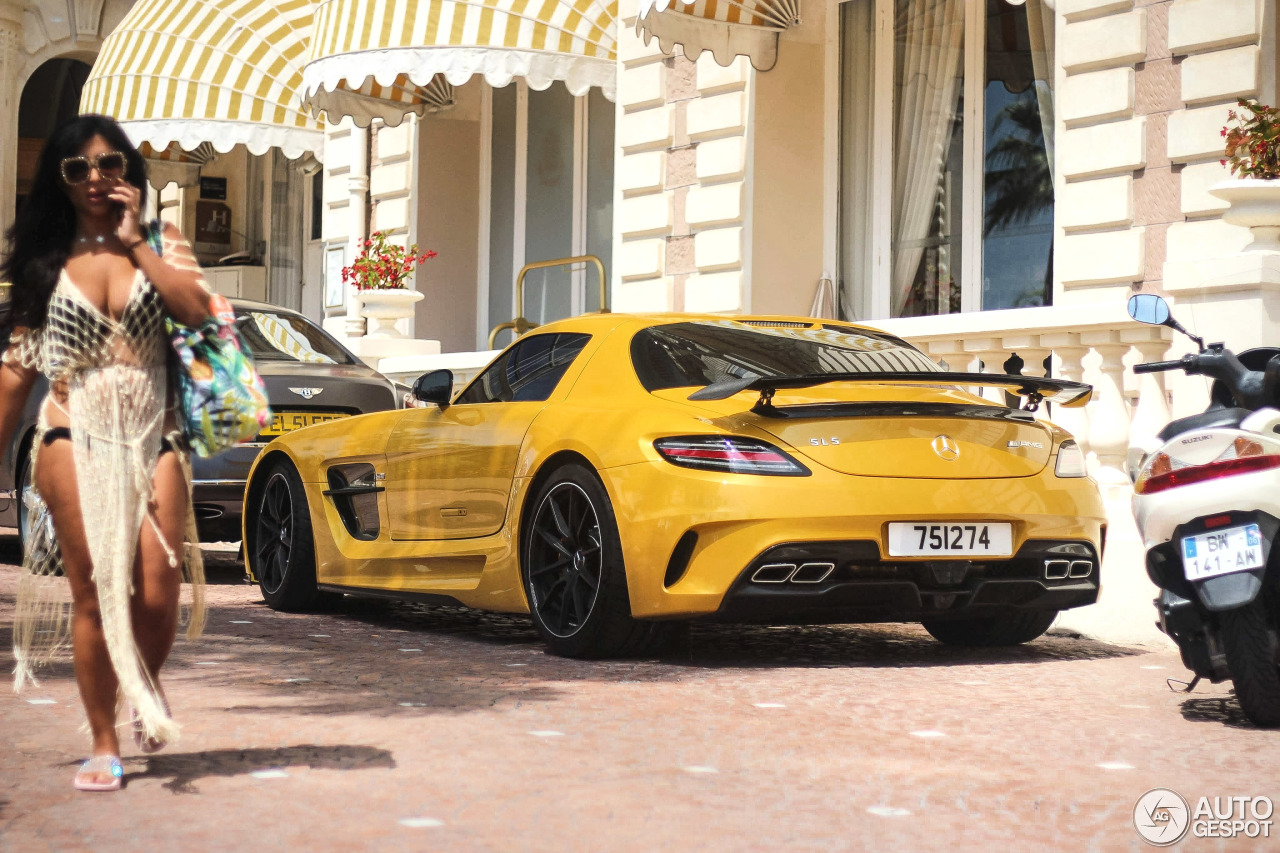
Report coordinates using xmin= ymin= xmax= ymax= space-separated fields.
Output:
xmin=868 ymin=302 xmax=1171 ymax=487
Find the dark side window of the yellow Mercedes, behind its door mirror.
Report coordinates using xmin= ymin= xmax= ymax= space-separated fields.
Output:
xmin=453 ymin=333 xmax=591 ymax=405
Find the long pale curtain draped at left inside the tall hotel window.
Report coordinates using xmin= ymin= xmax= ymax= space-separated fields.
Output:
xmin=892 ymin=0 xmax=962 ymax=316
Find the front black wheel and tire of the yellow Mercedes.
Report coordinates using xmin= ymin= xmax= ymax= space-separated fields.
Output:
xmin=246 ymin=460 xmax=326 ymax=612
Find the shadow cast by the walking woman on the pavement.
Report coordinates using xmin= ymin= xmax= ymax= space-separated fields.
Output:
xmin=124 ymin=744 xmax=396 ymax=794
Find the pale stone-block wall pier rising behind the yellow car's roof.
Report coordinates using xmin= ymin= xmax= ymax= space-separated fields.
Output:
xmin=612 ymin=4 xmax=754 ymax=311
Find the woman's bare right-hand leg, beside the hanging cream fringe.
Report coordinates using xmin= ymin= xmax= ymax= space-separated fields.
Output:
xmin=131 ymin=452 xmax=187 ymax=684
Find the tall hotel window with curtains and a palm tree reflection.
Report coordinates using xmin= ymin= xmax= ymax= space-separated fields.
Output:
xmin=840 ymin=0 xmax=1053 ymax=319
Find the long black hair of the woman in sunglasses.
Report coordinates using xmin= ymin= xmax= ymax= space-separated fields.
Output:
xmin=0 ymin=115 xmax=147 ymax=329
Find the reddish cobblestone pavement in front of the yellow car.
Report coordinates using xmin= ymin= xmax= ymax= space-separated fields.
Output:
xmin=0 ymin=538 xmax=1280 ymax=852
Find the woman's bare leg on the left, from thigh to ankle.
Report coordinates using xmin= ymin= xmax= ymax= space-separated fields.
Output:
xmin=35 ymin=439 xmax=120 ymax=768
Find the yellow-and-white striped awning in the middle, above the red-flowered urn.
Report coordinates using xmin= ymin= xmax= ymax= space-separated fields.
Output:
xmin=302 ymin=0 xmax=618 ymax=124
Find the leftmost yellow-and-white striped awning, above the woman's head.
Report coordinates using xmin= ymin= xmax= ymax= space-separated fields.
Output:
xmin=81 ymin=0 xmax=324 ymax=159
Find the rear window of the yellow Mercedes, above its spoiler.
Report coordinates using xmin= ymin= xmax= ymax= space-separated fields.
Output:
xmin=631 ymin=320 xmax=941 ymax=391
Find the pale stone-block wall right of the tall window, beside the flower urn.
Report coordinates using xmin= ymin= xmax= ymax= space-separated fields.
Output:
xmin=1056 ymin=0 xmax=1275 ymax=304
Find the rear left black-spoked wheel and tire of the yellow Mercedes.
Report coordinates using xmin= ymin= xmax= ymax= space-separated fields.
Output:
xmin=520 ymin=464 xmax=663 ymax=658
